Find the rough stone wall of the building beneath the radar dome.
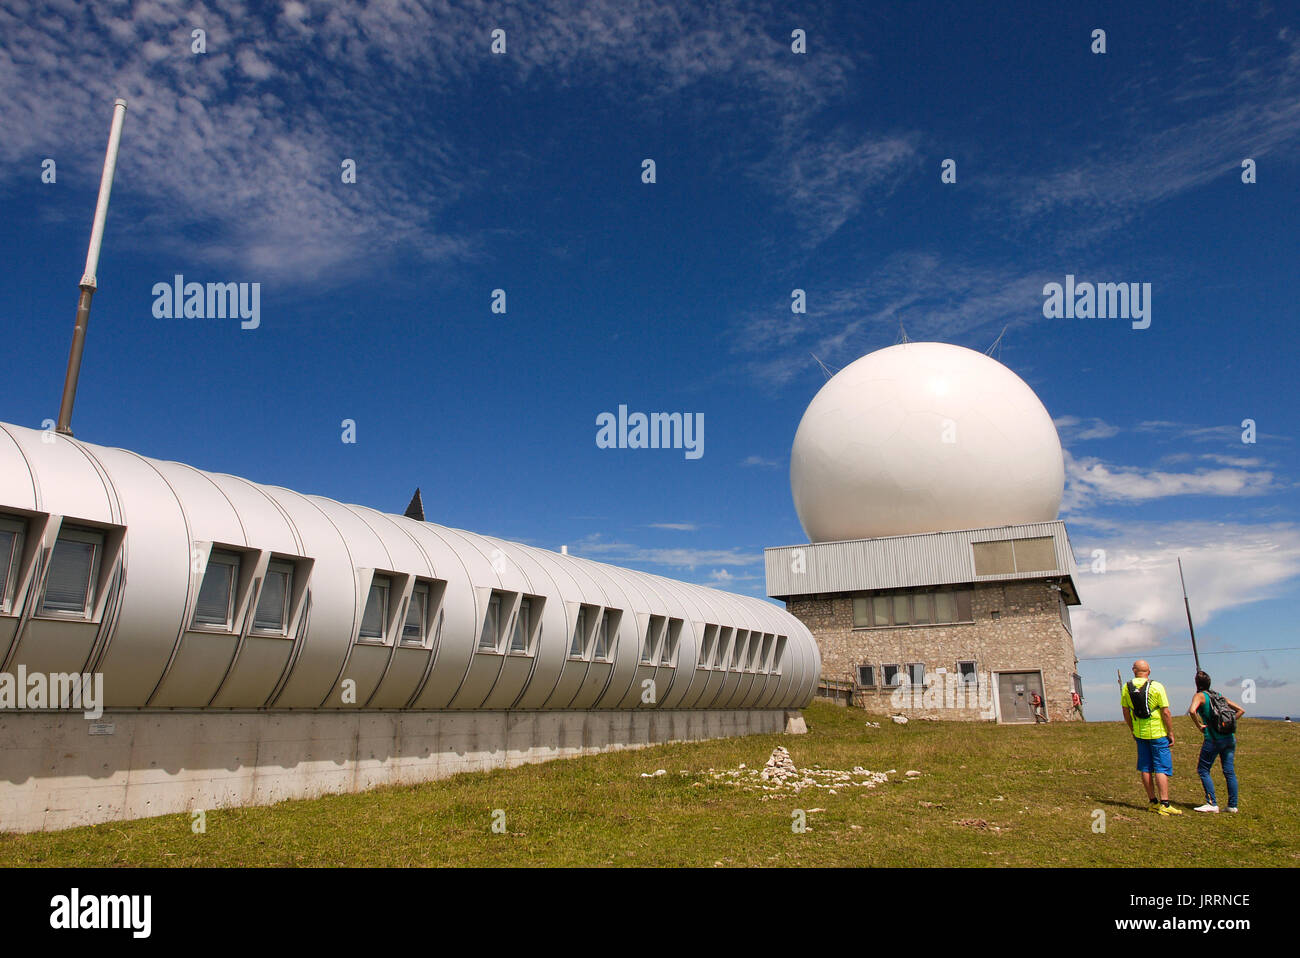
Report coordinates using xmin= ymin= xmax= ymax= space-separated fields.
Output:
xmin=787 ymin=581 xmax=1080 ymax=721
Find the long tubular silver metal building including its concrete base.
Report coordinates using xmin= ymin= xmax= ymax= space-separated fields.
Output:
xmin=0 ymin=422 xmax=820 ymax=831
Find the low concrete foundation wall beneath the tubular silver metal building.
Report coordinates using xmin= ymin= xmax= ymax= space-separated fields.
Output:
xmin=0 ymin=708 xmax=802 ymax=832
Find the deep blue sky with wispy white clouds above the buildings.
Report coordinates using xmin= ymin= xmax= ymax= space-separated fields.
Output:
xmin=0 ymin=0 xmax=1300 ymax=718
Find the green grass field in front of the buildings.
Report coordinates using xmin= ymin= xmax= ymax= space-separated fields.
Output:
xmin=0 ymin=703 xmax=1300 ymax=867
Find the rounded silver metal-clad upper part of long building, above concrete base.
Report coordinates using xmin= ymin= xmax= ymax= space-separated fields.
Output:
xmin=0 ymin=424 xmax=820 ymax=710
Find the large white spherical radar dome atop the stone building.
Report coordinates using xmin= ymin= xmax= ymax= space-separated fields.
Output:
xmin=790 ymin=343 xmax=1065 ymax=542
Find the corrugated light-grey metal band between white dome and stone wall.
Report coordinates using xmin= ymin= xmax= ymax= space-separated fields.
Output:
xmin=763 ymin=519 xmax=1078 ymax=604
